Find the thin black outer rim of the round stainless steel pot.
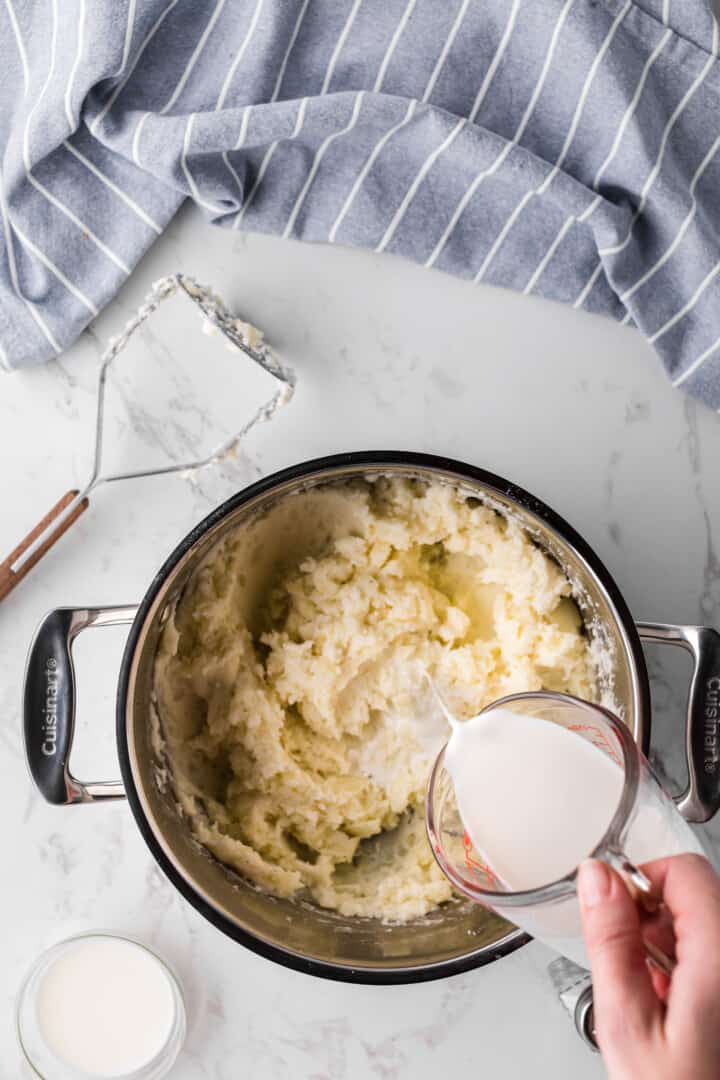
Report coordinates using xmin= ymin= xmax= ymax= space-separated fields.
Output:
xmin=116 ymin=450 xmax=650 ymax=985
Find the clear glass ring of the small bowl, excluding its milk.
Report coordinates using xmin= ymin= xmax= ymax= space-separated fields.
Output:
xmin=15 ymin=930 xmax=186 ymax=1080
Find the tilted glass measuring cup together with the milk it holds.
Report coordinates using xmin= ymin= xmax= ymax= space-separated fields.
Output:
xmin=425 ymin=692 xmax=702 ymax=970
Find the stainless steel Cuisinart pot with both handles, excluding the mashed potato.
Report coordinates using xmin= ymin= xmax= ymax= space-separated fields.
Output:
xmin=25 ymin=451 xmax=720 ymax=983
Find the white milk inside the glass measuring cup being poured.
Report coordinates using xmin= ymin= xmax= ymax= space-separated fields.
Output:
xmin=445 ymin=707 xmax=702 ymax=967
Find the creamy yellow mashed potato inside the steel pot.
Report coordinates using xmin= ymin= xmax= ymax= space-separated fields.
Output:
xmin=155 ymin=480 xmax=595 ymax=920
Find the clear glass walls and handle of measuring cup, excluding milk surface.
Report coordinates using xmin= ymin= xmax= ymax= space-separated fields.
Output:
xmin=425 ymin=692 xmax=702 ymax=971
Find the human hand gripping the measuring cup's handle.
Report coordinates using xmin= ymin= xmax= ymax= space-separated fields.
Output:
xmin=578 ymin=855 xmax=720 ymax=1080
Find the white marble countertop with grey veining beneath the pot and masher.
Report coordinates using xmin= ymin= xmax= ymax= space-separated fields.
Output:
xmin=0 ymin=204 xmax=720 ymax=1080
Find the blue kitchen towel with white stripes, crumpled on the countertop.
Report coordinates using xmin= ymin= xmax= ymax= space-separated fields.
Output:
xmin=0 ymin=0 xmax=720 ymax=408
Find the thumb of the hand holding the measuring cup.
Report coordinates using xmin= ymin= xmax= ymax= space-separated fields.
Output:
xmin=578 ymin=859 xmax=661 ymax=1052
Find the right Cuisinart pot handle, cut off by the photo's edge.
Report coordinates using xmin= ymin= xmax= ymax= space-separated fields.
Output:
xmin=637 ymin=622 xmax=720 ymax=824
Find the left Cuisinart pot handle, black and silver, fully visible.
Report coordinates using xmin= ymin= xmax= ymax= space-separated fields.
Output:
xmin=23 ymin=606 xmax=137 ymax=806
